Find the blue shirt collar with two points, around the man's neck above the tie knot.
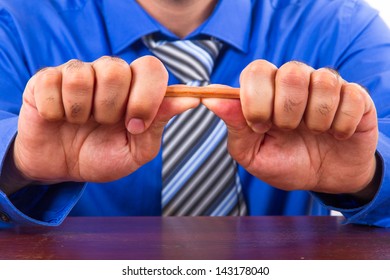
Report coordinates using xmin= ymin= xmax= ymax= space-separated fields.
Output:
xmin=102 ymin=0 xmax=252 ymax=53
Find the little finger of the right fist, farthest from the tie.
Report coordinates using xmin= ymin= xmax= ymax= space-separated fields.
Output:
xmin=332 ymin=83 xmax=368 ymax=140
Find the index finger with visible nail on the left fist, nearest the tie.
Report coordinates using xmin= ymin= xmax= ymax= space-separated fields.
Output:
xmin=126 ymin=56 xmax=168 ymax=134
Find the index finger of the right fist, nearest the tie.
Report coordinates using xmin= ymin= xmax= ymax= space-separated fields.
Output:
xmin=240 ymin=60 xmax=277 ymax=133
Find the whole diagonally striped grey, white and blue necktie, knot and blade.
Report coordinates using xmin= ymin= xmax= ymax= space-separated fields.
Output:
xmin=143 ymin=35 xmax=247 ymax=216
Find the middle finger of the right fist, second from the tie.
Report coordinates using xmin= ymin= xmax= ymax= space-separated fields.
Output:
xmin=273 ymin=61 xmax=313 ymax=129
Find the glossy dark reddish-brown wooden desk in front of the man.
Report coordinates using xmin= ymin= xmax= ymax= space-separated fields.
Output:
xmin=0 ymin=217 xmax=390 ymax=260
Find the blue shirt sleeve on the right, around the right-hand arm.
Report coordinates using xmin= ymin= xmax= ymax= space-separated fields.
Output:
xmin=314 ymin=1 xmax=390 ymax=227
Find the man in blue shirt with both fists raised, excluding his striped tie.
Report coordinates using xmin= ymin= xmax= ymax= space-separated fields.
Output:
xmin=0 ymin=0 xmax=390 ymax=226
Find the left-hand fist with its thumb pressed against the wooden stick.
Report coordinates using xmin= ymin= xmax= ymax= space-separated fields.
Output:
xmin=13 ymin=57 xmax=199 ymax=188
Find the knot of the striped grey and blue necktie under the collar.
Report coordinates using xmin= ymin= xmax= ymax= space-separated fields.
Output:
xmin=143 ymin=34 xmax=222 ymax=86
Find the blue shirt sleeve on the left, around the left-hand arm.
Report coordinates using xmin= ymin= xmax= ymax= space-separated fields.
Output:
xmin=0 ymin=9 xmax=84 ymax=227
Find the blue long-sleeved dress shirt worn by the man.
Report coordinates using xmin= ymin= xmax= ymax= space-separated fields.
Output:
xmin=0 ymin=0 xmax=390 ymax=226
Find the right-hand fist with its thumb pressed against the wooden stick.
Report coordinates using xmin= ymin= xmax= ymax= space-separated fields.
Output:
xmin=203 ymin=60 xmax=378 ymax=193
